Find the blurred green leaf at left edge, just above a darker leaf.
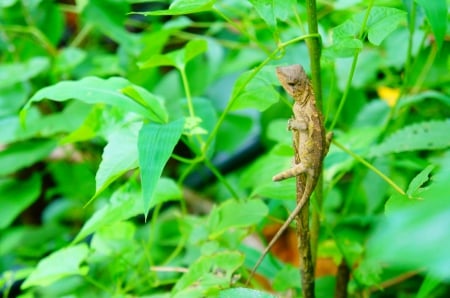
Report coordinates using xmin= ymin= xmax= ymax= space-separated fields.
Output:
xmin=0 ymin=140 xmax=56 ymax=175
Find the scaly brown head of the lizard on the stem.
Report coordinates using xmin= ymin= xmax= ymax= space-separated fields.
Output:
xmin=276 ymin=64 xmax=308 ymax=100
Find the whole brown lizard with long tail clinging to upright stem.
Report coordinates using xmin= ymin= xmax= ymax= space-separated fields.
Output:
xmin=247 ymin=64 xmax=331 ymax=283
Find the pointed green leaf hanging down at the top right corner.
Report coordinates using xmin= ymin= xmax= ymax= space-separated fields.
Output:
xmin=415 ymin=0 xmax=448 ymax=48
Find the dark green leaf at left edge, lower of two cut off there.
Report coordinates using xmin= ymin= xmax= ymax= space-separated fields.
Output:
xmin=0 ymin=174 xmax=41 ymax=230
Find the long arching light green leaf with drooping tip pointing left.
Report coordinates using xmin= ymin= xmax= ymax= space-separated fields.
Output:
xmin=21 ymin=77 xmax=154 ymax=119
